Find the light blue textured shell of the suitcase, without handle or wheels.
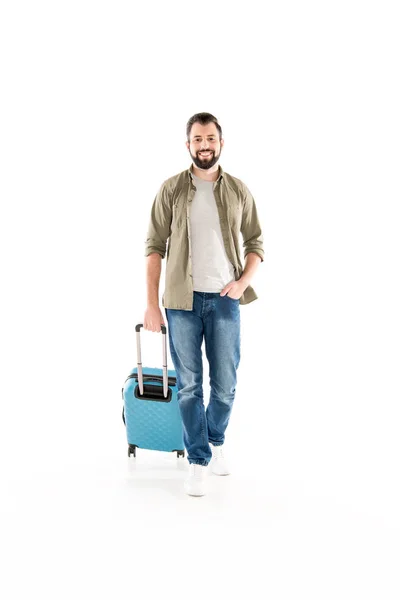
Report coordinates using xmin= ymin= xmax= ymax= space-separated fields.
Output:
xmin=122 ymin=367 xmax=184 ymax=452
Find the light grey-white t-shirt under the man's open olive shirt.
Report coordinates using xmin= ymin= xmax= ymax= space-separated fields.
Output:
xmin=190 ymin=175 xmax=235 ymax=292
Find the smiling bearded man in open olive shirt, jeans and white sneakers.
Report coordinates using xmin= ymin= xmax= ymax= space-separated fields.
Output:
xmin=143 ymin=113 xmax=264 ymax=496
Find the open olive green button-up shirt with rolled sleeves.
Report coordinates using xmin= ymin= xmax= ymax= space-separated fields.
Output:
xmin=145 ymin=164 xmax=264 ymax=310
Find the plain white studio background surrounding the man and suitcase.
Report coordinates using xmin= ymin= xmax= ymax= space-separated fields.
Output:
xmin=0 ymin=0 xmax=400 ymax=600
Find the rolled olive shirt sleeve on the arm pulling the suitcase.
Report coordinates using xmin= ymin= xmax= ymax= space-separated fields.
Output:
xmin=145 ymin=181 xmax=172 ymax=258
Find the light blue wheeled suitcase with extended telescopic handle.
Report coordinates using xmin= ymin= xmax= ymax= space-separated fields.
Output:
xmin=122 ymin=323 xmax=185 ymax=457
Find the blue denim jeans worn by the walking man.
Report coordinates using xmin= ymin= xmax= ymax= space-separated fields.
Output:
xmin=165 ymin=292 xmax=240 ymax=465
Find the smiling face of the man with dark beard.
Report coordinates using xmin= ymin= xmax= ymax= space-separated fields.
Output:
xmin=186 ymin=123 xmax=224 ymax=171
